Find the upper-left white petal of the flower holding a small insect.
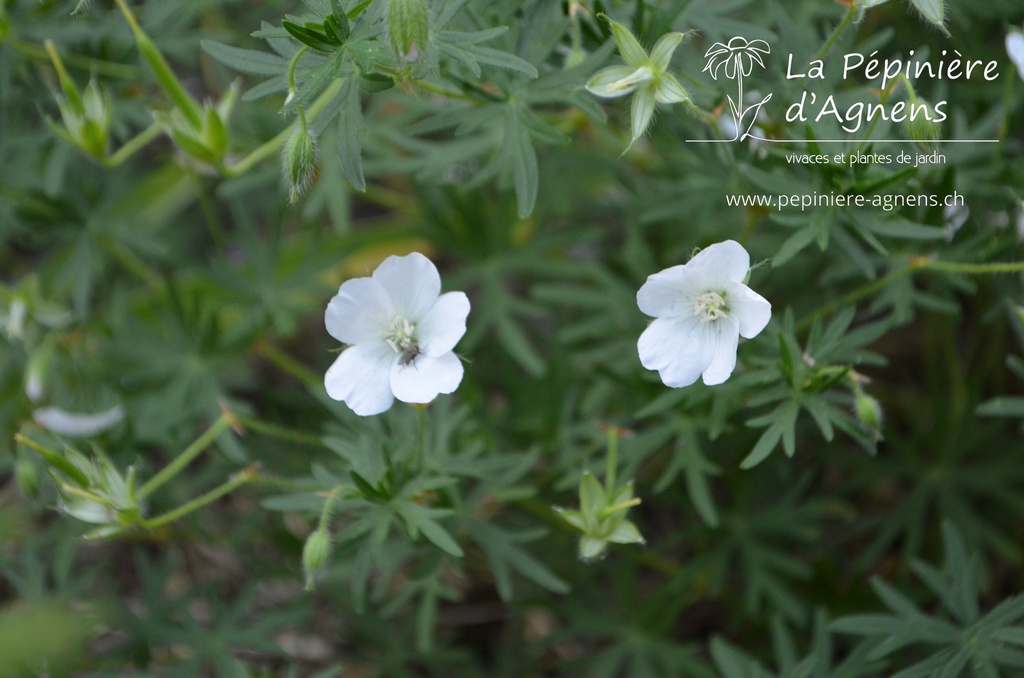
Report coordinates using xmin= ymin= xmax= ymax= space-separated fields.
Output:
xmin=324 ymin=278 xmax=395 ymax=344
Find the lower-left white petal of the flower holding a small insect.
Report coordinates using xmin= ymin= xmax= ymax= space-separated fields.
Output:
xmin=324 ymin=343 xmax=398 ymax=417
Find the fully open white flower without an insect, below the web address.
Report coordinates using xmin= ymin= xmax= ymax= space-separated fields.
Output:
xmin=637 ymin=240 xmax=771 ymax=388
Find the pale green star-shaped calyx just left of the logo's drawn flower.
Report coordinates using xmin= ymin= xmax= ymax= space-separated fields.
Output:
xmin=586 ymin=22 xmax=690 ymax=141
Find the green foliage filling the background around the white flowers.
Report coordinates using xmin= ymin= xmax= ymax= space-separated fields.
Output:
xmin=0 ymin=0 xmax=1024 ymax=678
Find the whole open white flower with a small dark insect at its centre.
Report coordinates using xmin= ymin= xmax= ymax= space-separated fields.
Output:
xmin=324 ymin=252 xmax=469 ymax=416
